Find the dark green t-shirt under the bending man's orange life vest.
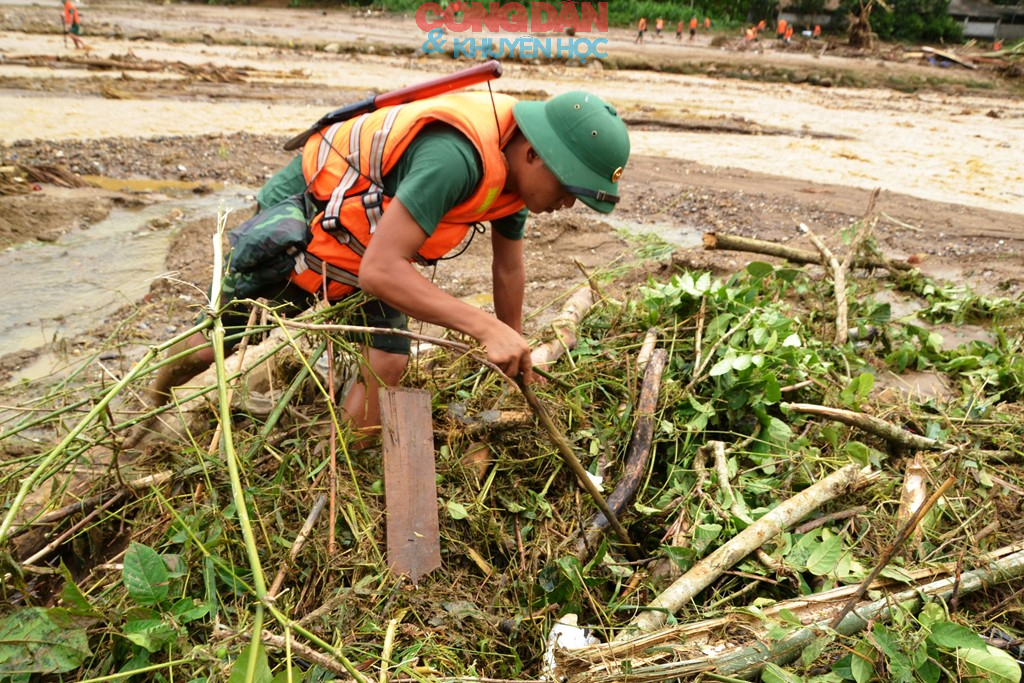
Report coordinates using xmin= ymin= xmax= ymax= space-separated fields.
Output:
xmin=256 ymin=123 xmax=528 ymax=240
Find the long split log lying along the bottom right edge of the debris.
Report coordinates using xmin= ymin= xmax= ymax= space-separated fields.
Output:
xmin=555 ymin=544 xmax=1024 ymax=683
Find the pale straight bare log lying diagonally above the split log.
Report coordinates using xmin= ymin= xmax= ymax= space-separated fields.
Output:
xmin=615 ymin=465 xmax=869 ymax=642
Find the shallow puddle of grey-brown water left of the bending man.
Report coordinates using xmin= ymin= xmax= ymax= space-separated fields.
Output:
xmin=0 ymin=187 xmax=252 ymax=354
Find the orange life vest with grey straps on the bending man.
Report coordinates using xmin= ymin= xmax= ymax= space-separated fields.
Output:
xmin=291 ymin=93 xmax=525 ymax=300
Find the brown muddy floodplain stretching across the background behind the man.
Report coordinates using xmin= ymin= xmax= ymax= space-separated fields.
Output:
xmin=0 ymin=0 xmax=1024 ymax=380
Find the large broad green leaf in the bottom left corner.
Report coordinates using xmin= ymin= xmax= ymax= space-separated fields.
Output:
xmin=0 ymin=607 xmax=92 ymax=676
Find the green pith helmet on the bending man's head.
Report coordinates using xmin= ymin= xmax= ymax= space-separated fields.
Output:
xmin=512 ymin=90 xmax=630 ymax=213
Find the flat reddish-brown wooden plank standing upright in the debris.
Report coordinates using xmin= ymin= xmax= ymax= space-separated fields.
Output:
xmin=380 ymin=388 xmax=441 ymax=584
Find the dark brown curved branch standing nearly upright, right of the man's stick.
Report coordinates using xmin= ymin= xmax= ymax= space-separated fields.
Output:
xmin=577 ymin=348 xmax=668 ymax=558
